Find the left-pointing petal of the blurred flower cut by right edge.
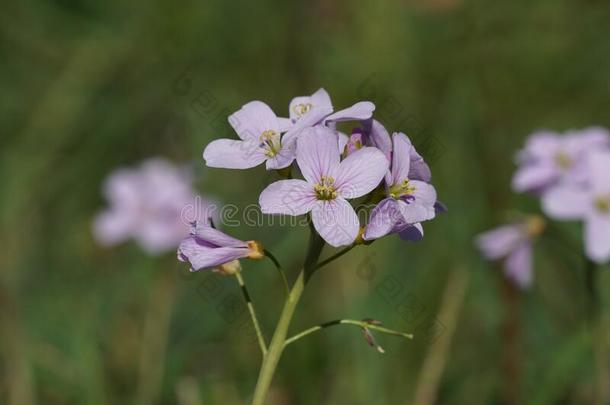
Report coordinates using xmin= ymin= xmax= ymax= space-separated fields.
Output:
xmin=542 ymin=185 xmax=592 ymax=220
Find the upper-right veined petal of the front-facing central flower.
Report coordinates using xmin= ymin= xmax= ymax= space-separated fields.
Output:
xmin=333 ymin=147 xmax=389 ymax=198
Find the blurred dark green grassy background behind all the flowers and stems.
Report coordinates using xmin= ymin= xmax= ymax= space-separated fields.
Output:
xmin=0 ymin=0 xmax=610 ymax=405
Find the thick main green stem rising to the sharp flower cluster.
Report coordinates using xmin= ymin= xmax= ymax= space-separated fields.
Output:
xmin=252 ymin=231 xmax=324 ymax=405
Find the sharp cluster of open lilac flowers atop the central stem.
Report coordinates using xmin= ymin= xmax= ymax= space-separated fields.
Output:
xmin=197 ymin=89 xmax=440 ymax=252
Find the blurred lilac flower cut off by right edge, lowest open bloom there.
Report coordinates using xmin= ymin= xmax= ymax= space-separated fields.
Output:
xmin=542 ymin=151 xmax=610 ymax=263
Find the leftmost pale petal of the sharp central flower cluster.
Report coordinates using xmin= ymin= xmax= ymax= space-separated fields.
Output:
xmin=203 ymin=139 xmax=267 ymax=169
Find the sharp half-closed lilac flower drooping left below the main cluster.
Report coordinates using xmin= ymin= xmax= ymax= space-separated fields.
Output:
xmin=177 ymin=223 xmax=264 ymax=273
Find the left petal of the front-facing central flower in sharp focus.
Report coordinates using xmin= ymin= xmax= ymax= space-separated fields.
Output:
xmin=259 ymin=180 xmax=316 ymax=216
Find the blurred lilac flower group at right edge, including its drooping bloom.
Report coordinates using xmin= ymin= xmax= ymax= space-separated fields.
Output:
xmin=477 ymin=127 xmax=610 ymax=286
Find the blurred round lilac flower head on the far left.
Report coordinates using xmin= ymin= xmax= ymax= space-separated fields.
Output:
xmin=93 ymin=158 xmax=216 ymax=254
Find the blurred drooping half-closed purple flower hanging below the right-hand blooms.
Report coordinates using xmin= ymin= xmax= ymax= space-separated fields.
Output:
xmin=475 ymin=217 xmax=545 ymax=288
